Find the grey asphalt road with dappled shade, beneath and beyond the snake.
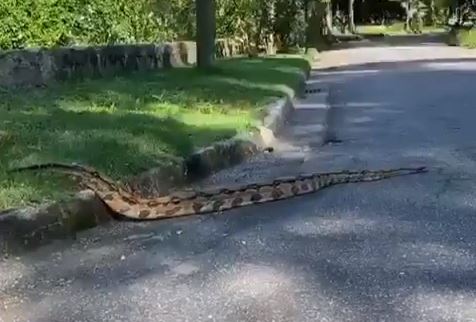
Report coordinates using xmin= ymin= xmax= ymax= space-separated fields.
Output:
xmin=0 ymin=34 xmax=476 ymax=322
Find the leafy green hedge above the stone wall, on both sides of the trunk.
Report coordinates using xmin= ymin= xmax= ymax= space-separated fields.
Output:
xmin=0 ymin=0 xmax=316 ymax=49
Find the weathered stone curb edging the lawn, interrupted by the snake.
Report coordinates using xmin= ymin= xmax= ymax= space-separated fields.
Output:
xmin=0 ymin=66 xmax=311 ymax=254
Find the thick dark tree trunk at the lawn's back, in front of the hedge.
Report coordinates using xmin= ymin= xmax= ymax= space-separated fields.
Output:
xmin=195 ymin=0 xmax=216 ymax=69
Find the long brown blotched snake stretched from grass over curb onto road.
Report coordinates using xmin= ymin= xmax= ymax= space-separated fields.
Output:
xmin=10 ymin=163 xmax=427 ymax=220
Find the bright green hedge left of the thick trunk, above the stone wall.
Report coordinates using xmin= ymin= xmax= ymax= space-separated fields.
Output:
xmin=0 ymin=0 xmax=194 ymax=49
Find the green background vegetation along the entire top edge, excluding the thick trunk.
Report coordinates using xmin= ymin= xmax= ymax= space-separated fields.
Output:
xmin=0 ymin=0 xmax=473 ymax=49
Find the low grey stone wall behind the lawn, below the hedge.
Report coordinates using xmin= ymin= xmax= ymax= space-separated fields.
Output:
xmin=0 ymin=39 xmax=249 ymax=87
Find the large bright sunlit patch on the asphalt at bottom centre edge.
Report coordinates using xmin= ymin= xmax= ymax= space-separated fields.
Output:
xmin=212 ymin=258 xmax=360 ymax=321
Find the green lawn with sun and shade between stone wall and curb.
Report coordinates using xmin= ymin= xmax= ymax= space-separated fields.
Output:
xmin=0 ymin=55 xmax=308 ymax=209
